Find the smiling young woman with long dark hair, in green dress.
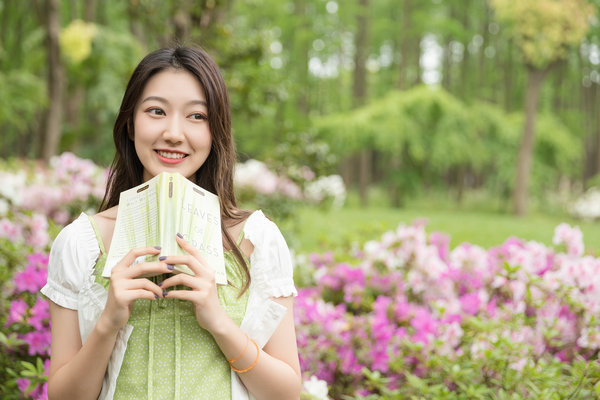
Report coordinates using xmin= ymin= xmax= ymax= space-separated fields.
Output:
xmin=42 ymin=47 xmax=301 ymax=400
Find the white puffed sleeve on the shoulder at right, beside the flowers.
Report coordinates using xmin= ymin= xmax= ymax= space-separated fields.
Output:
xmin=244 ymin=210 xmax=298 ymax=297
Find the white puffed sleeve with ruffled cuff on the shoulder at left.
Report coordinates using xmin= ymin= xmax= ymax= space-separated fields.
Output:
xmin=41 ymin=213 xmax=100 ymax=310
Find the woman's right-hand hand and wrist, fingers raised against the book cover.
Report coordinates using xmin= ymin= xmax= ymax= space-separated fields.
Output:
xmin=156 ymin=235 xmax=228 ymax=333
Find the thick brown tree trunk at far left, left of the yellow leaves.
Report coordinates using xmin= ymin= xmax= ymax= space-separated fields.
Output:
xmin=41 ymin=0 xmax=64 ymax=162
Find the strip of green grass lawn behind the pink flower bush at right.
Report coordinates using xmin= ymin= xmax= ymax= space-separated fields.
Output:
xmin=290 ymin=205 xmax=600 ymax=253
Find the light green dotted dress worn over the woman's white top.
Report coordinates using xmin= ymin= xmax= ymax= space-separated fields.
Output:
xmin=90 ymin=218 xmax=249 ymax=400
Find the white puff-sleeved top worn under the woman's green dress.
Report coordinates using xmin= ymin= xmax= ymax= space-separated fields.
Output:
xmin=41 ymin=210 xmax=297 ymax=400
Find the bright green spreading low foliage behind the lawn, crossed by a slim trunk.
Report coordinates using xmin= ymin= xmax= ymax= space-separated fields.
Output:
xmin=315 ymin=86 xmax=582 ymax=206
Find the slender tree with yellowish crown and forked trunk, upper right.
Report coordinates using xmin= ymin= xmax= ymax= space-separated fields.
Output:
xmin=491 ymin=0 xmax=594 ymax=215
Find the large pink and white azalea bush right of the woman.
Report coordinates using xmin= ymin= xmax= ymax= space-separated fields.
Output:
xmin=295 ymin=221 xmax=600 ymax=398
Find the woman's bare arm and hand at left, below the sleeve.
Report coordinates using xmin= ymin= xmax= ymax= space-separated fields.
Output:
xmin=48 ymin=247 xmax=170 ymax=400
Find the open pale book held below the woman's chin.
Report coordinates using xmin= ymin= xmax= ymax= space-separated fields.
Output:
xmin=102 ymin=172 xmax=227 ymax=285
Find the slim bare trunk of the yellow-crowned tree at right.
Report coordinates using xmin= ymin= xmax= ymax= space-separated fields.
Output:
xmin=513 ymin=67 xmax=548 ymax=216
